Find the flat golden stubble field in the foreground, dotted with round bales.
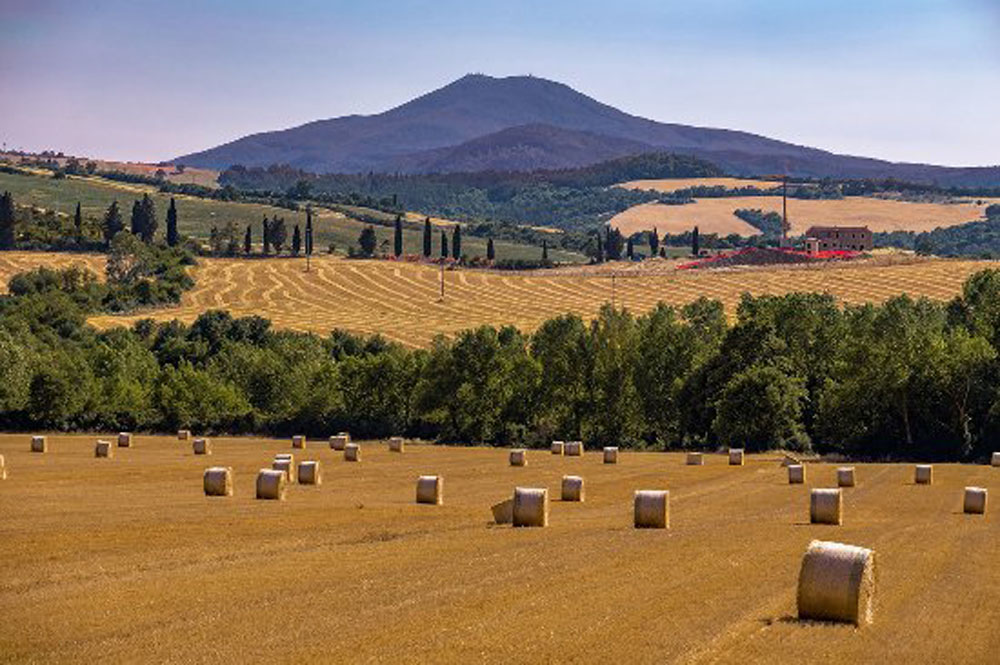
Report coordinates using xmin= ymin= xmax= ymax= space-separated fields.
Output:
xmin=0 ymin=434 xmax=1000 ymax=663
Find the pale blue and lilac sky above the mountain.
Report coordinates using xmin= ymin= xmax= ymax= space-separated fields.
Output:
xmin=0 ymin=0 xmax=1000 ymax=166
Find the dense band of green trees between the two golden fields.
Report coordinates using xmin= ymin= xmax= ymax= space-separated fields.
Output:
xmin=0 ymin=264 xmax=1000 ymax=460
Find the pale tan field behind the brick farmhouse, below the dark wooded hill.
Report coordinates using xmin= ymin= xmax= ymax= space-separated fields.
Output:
xmin=610 ymin=196 xmax=997 ymax=236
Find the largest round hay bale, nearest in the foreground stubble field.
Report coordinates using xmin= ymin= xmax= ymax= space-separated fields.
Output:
xmin=797 ymin=540 xmax=875 ymax=626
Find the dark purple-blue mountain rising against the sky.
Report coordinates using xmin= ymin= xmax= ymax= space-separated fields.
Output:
xmin=180 ymin=74 xmax=1000 ymax=186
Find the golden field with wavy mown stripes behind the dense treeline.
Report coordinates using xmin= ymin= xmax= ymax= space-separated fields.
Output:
xmin=91 ymin=257 xmax=996 ymax=346
